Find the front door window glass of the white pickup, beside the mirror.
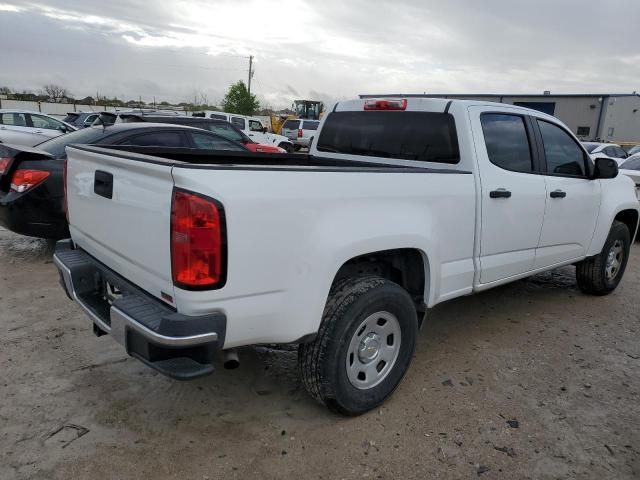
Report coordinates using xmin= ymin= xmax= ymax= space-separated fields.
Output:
xmin=538 ymin=120 xmax=587 ymax=177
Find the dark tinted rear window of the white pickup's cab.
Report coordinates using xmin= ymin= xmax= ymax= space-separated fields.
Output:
xmin=316 ymin=111 xmax=460 ymax=164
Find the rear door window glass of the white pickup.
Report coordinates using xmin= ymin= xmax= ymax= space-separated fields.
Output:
xmin=480 ymin=113 xmax=533 ymax=173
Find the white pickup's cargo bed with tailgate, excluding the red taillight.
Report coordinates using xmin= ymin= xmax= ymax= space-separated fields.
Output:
xmin=67 ymin=146 xmax=476 ymax=348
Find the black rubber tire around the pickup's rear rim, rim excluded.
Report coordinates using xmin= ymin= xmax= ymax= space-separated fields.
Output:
xmin=298 ymin=275 xmax=418 ymax=416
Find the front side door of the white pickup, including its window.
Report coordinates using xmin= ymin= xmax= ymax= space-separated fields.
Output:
xmin=533 ymin=119 xmax=600 ymax=268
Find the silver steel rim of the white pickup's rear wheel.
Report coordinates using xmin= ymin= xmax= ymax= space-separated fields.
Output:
xmin=345 ymin=311 xmax=402 ymax=390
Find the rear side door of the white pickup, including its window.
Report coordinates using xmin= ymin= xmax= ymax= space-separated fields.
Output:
xmin=470 ymin=107 xmax=546 ymax=284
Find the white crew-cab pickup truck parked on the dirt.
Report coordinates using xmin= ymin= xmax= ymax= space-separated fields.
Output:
xmin=54 ymin=98 xmax=639 ymax=415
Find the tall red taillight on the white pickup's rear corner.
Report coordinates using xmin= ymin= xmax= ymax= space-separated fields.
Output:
xmin=171 ymin=190 xmax=226 ymax=290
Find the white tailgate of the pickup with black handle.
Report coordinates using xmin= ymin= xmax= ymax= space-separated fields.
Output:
xmin=67 ymin=147 xmax=174 ymax=303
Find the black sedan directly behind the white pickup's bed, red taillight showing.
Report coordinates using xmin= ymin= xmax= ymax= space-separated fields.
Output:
xmin=0 ymin=123 xmax=249 ymax=239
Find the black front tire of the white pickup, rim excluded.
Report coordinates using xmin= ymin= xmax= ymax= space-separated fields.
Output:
xmin=576 ymin=220 xmax=631 ymax=295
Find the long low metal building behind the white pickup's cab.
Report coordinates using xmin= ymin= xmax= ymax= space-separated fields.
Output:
xmin=360 ymin=92 xmax=640 ymax=143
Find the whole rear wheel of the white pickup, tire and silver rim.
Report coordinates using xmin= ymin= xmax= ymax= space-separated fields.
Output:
xmin=298 ymin=276 xmax=418 ymax=415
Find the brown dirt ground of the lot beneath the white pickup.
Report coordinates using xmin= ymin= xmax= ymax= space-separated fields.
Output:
xmin=0 ymin=230 xmax=640 ymax=480
